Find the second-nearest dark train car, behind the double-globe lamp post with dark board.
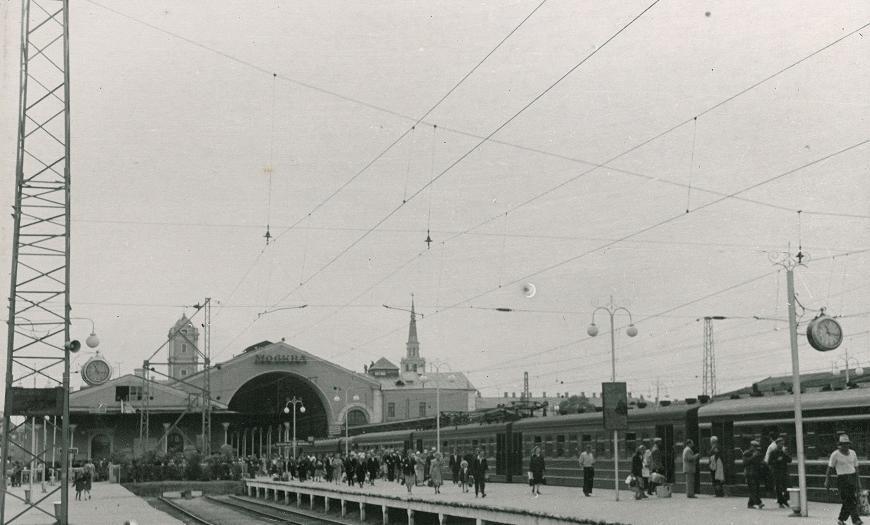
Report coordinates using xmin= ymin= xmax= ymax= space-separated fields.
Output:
xmin=508 ymin=404 xmax=699 ymax=489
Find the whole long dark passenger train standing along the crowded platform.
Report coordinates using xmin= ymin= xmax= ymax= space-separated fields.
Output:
xmin=307 ymin=389 xmax=870 ymax=500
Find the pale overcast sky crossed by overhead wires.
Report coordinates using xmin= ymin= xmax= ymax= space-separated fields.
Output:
xmin=0 ymin=0 xmax=870 ymax=398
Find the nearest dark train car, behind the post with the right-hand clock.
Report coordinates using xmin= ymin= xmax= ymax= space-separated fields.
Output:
xmin=698 ymin=388 xmax=870 ymax=501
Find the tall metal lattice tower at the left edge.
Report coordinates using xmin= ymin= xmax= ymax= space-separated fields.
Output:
xmin=0 ymin=0 xmax=70 ymax=525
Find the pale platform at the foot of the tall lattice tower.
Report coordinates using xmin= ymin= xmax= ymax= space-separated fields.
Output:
xmin=5 ymin=482 xmax=184 ymax=525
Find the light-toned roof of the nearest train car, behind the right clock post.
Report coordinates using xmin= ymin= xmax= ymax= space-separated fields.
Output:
xmin=698 ymin=388 xmax=870 ymax=420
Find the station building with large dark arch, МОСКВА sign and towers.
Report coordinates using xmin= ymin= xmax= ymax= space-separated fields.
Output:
xmin=65 ymin=303 xmax=478 ymax=460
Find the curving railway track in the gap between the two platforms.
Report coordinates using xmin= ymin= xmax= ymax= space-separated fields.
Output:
xmin=160 ymin=496 xmax=347 ymax=525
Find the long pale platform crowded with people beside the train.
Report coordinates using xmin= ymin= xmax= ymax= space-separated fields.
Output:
xmin=247 ymin=478 xmax=852 ymax=525
